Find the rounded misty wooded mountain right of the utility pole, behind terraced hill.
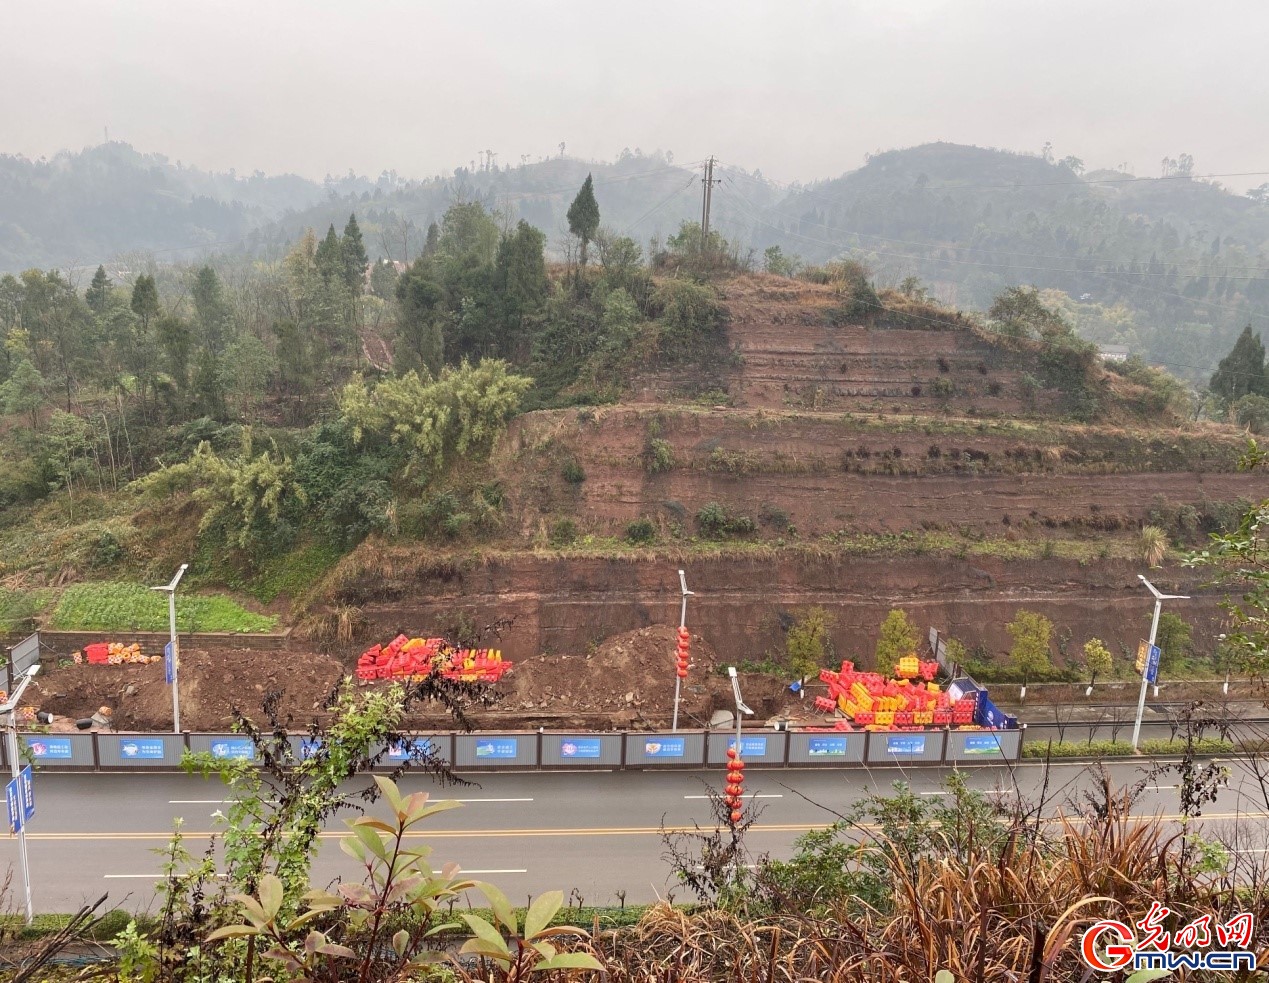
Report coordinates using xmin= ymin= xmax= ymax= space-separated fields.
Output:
xmin=718 ymin=143 xmax=1269 ymax=382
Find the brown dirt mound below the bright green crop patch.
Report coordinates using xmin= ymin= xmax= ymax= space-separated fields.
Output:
xmin=28 ymin=649 xmax=344 ymax=731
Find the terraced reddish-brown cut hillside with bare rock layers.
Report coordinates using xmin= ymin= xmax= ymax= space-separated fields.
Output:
xmin=329 ymin=277 xmax=1263 ymax=662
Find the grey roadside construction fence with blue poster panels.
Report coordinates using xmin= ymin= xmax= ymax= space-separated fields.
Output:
xmin=0 ymin=731 xmax=1023 ymax=772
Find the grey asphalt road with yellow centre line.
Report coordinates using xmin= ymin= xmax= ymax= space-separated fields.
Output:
xmin=0 ymin=760 xmax=1269 ymax=912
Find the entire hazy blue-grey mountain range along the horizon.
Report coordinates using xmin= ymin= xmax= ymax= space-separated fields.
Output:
xmin=0 ymin=143 xmax=1269 ymax=381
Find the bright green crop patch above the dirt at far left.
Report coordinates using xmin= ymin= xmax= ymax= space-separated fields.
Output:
xmin=49 ymin=582 xmax=278 ymax=632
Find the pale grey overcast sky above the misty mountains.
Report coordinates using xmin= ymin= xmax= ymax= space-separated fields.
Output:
xmin=0 ymin=0 xmax=1269 ymax=189
